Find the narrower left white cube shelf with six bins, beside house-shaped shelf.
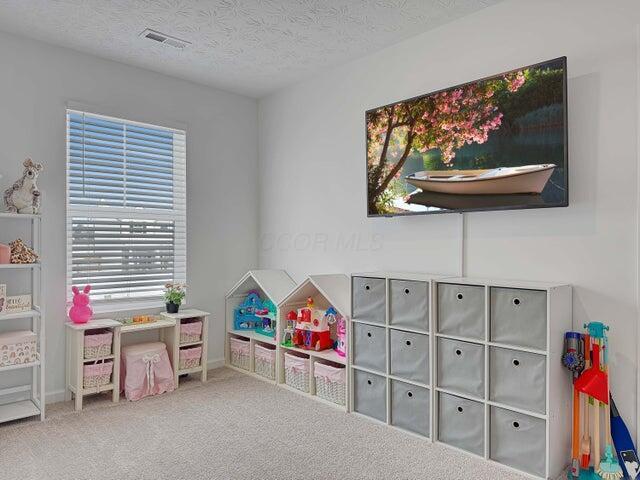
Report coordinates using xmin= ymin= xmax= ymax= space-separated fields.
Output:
xmin=349 ymin=272 xmax=434 ymax=438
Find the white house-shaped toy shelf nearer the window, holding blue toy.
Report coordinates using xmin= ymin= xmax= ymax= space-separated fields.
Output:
xmin=225 ymin=270 xmax=296 ymax=383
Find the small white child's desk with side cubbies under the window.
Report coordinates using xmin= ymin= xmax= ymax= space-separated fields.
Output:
xmin=65 ymin=309 xmax=209 ymax=410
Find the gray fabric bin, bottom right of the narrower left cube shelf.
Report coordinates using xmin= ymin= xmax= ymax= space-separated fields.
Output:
xmin=391 ymin=380 xmax=430 ymax=437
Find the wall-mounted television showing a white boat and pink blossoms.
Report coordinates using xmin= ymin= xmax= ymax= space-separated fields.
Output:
xmin=365 ymin=57 xmax=569 ymax=216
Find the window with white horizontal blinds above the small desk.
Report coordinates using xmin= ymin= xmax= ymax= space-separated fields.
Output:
xmin=67 ymin=110 xmax=186 ymax=302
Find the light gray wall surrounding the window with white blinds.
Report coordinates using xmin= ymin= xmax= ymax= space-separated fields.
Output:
xmin=0 ymin=33 xmax=258 ymax=398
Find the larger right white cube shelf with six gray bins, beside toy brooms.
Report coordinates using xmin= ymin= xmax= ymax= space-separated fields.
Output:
xmin=432 ymin=278 xmax=572 ymax=479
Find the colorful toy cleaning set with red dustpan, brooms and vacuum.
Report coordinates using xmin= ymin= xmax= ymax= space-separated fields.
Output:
xmin=562 ymin=322 xmax=638 ymax=480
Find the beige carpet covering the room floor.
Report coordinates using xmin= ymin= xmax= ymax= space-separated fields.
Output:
xmin=0 ymin=369 xmax=524 ymax=480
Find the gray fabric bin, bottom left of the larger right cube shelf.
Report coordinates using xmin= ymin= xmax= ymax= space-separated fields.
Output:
xmin=438 ymin=392 xmax=484 ymax=455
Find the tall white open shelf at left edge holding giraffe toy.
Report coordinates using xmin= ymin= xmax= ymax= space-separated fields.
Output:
xmin=0 ymin=213 xmax=46 ymax=423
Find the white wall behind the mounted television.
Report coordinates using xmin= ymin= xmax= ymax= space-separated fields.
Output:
xmin=259 ymin=0 xmax=640 ymax=429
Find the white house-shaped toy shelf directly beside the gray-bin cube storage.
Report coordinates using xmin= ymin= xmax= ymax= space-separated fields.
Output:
xmin=276 ymin=274 xmax=350 ymax=411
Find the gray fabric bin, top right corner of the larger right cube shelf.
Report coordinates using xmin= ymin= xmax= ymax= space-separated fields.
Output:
xmin=491 ymin=287 xmax=547 ymax=350
